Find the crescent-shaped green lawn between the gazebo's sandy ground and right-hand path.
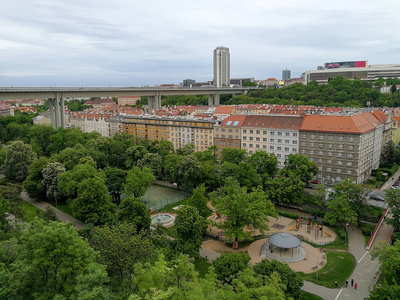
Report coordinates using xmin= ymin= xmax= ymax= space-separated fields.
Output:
xmin=299 ymin=250 xmax=356 ymax=288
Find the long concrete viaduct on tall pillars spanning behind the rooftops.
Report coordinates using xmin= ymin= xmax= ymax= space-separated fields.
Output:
xmin=0 ymin=87 xmax=258 ymax=128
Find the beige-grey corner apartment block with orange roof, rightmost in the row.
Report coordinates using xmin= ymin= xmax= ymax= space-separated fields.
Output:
xmin=299 ymin=114 xmax=382 ymax=184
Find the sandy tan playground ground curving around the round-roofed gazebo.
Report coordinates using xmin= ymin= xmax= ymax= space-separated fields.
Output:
xmin=203 ymin=203 xmax=336 ymax=274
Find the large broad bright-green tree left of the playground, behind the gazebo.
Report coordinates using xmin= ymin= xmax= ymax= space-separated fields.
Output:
xmin=210 ymin=179 xmax=277 ymax=244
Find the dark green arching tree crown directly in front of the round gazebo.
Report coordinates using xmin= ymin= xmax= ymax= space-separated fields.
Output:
xmin=254 ymin=259 xmax=303 ymax=299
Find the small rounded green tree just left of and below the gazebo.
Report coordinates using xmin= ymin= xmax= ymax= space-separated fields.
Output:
xmin=213 ymin=252 xmax=250 ymax=284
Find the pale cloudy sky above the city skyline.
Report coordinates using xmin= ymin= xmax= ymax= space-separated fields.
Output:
xmin=0 ymin=0 xmax=400 ymax=86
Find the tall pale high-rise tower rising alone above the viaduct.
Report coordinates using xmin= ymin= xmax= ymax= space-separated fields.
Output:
xmin=214 ymin=47 xmax=231 ymax=87
